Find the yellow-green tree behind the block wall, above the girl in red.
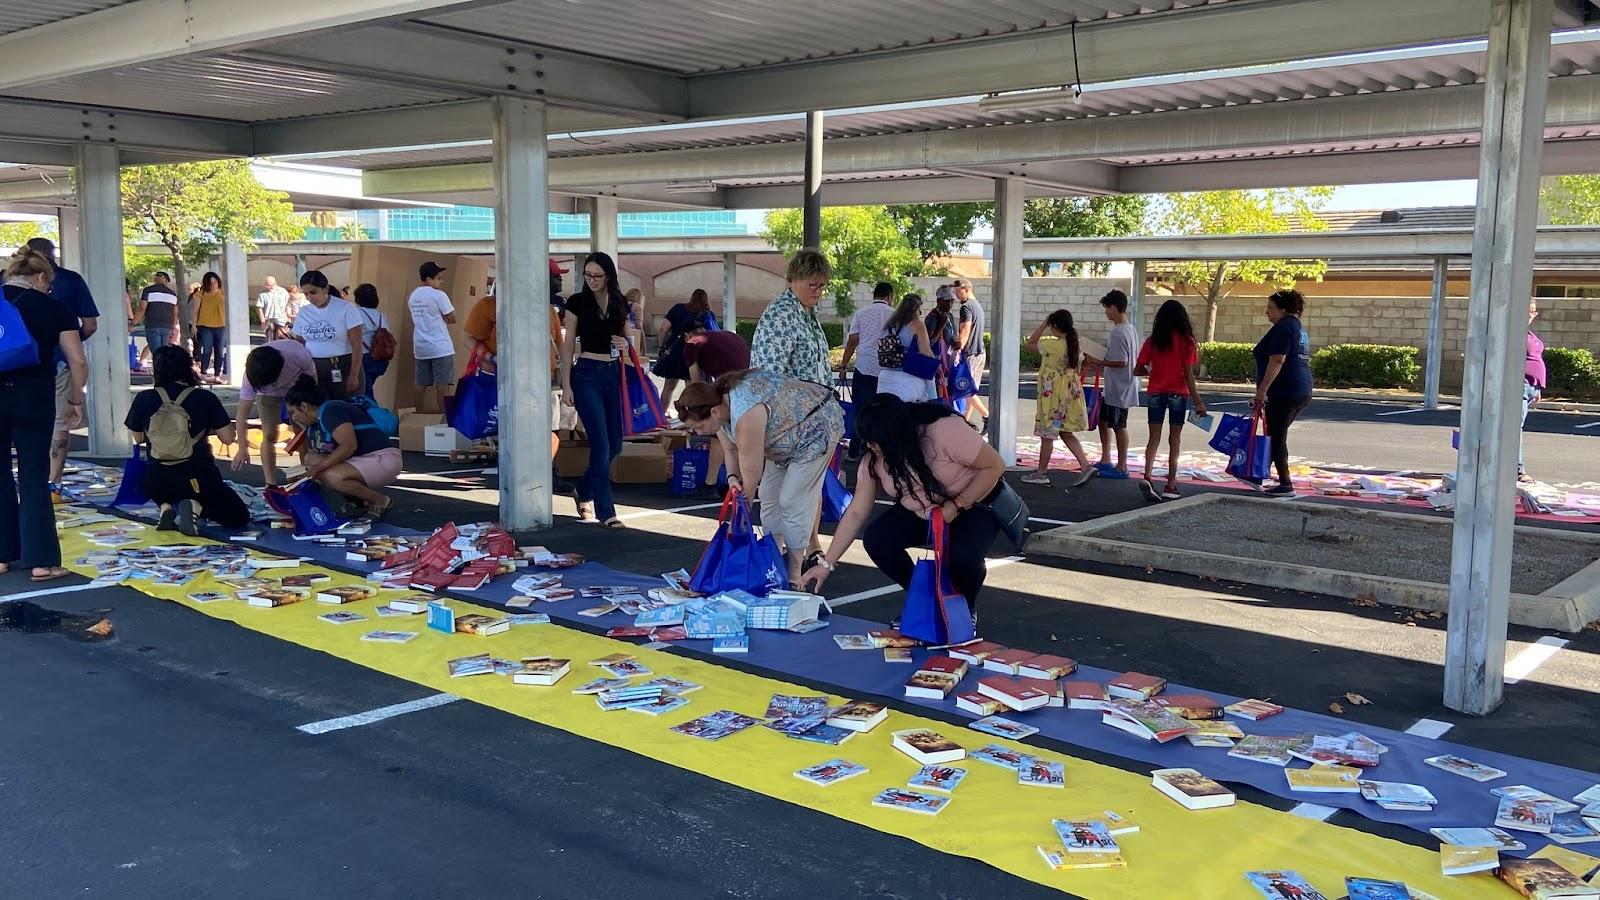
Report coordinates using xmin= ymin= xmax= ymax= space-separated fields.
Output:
xmin=1154 ymin=187 xmax=1333 ymax=341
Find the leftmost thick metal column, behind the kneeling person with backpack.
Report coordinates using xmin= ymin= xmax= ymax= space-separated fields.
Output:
xmin=77 ymin=144 xmax=133 ymax=456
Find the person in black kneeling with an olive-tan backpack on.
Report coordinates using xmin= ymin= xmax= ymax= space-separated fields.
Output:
xmin=123 ymin=344 xmax=250 ymax=536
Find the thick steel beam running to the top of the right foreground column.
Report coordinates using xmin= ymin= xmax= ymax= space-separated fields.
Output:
xmin=690 ymin=0 xmax=1486 ymax=119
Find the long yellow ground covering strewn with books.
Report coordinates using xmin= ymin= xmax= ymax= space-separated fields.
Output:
xmin=61 ymin=530 xmax=1506 ymax=900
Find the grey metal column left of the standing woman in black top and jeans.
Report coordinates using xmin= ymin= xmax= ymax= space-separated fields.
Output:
xmin=490 ymin=96 xmax=554 ymax=532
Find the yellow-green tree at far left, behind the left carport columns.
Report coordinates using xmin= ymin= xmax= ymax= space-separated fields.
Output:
xmin=122 ymin=160 xmax=306 ymax=335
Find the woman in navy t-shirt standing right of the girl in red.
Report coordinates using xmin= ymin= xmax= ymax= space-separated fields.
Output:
xmin=1254 ymin=290 xmax=1312 ymax=496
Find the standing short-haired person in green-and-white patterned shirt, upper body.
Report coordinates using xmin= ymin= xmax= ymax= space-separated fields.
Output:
xmin=750 ymin=250 xmax=834 ymax=384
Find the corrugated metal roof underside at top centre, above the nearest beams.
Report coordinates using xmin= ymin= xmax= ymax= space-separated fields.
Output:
xmin=424 ymin=0 xmax=1232 ymax=74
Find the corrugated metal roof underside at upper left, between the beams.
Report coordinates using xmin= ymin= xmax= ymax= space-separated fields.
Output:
xmin=16 ymin=54 xmax=464 ymax=122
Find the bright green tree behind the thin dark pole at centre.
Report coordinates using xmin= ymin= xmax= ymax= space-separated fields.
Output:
xmin=762 ymin=207 xmax=922 ymax=315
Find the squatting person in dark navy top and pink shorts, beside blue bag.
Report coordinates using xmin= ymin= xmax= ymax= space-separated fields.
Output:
xmin=283 ymin=375 xmax=402 ymax=520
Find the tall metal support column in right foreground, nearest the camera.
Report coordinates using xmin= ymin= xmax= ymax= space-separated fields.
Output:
xmin=1445 ymin=0 xmax=1552 ymax=716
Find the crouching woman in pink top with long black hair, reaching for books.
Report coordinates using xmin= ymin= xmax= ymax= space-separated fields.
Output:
xmin=800 ymin=394 xmax=1005 ymax=607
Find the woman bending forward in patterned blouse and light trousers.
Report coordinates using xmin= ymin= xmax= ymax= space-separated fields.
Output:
xmin=678 ymin=368 xmax=851 ymax=585
